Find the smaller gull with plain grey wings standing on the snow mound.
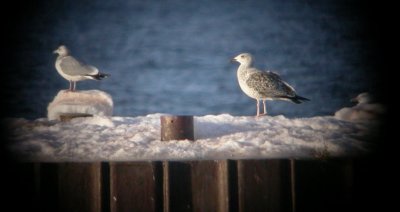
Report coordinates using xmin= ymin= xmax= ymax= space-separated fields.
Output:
xmin=54 ymin=45 xmax=109 ymax=91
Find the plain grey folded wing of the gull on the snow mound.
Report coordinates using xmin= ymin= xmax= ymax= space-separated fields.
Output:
xmin=60 ymin=56 xmax=98 ymax=76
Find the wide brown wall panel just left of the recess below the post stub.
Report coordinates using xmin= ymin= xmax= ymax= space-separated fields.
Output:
xmin=110 ymin=162 xmax=162 ymax=212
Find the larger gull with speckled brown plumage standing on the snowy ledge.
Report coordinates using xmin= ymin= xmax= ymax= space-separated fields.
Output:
xmin=232 ymin=53 xmax=309 ymax=116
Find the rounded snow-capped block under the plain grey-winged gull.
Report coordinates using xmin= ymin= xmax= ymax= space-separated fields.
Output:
xmin=47 ymin=90 xmax=113 ymax=120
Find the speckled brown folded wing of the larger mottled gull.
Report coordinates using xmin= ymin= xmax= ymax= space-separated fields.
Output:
xmin=246 ymin=71 xmax=296 ymax=98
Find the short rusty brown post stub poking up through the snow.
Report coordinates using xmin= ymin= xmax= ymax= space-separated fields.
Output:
xmin=160 ymin=116 xmax=194 ymax=141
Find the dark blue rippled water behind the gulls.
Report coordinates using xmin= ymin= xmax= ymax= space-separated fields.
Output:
xmin=5 ymin=0 xmax=374 ymax=118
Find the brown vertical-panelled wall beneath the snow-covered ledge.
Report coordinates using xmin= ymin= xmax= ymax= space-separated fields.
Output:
xmin=5 ymin=158 xmax=378 ymax=212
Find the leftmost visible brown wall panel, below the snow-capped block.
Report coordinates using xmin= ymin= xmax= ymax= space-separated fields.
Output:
xmin=58 ymin=162 xmax=101 ymax=212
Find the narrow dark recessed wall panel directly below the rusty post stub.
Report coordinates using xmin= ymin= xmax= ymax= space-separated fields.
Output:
xmin=163 ymin=161 xmax=193 ymax=212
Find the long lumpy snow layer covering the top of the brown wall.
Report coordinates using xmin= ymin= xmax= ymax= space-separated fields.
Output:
xmin=5 ymin=92 xmax=384 ymax=162
